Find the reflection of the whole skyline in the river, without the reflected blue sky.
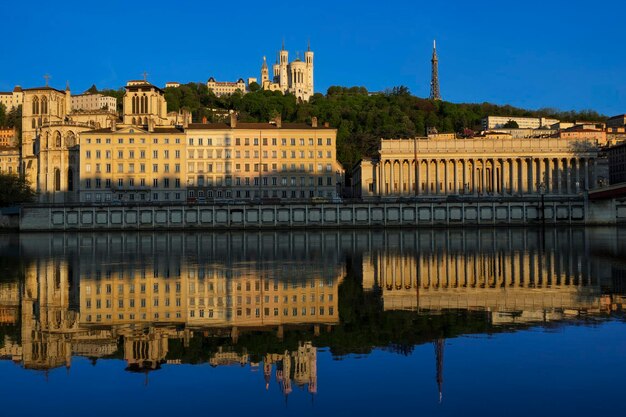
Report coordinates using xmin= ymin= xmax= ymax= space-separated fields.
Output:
xmin=0 ymin=229 xmax=624 ymax=395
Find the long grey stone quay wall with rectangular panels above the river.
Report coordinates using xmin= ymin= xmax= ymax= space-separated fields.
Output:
xmin=20 ymin=199 xmax=608 ymax=231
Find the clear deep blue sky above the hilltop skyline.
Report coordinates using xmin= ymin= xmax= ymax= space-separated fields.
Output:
xmin=0 ymin=0 xmax=626 ymax=115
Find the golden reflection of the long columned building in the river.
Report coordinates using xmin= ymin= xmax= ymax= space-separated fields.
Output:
xmin=362 ymin=229 xmax=622 ymax=324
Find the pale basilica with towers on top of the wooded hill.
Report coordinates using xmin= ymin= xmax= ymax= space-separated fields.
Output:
xmin=261 ymin=42 xmax=315 ymax=101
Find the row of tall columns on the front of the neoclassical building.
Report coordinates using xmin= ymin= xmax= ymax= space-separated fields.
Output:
xmin=376 ymin=157 xmax=598 ymax=196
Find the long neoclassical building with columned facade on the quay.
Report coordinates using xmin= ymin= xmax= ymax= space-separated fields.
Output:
xmin=353 ymin=135 xmax=602 ymax=199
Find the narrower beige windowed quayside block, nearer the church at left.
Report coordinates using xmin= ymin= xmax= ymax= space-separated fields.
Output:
xmin=79 ymin=124 xmax=186 ymax=203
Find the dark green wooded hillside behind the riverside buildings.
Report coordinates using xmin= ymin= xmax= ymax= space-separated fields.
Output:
xmin=158 ymin=83 xmax=606 ymax=168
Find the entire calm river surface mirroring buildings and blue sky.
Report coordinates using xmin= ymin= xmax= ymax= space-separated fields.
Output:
xmin=0 ymin=228 xmax=626 ymax=416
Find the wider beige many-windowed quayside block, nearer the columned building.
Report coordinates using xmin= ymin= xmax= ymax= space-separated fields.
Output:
xmin=186 ymin=114 xmax=343 ymax=201
